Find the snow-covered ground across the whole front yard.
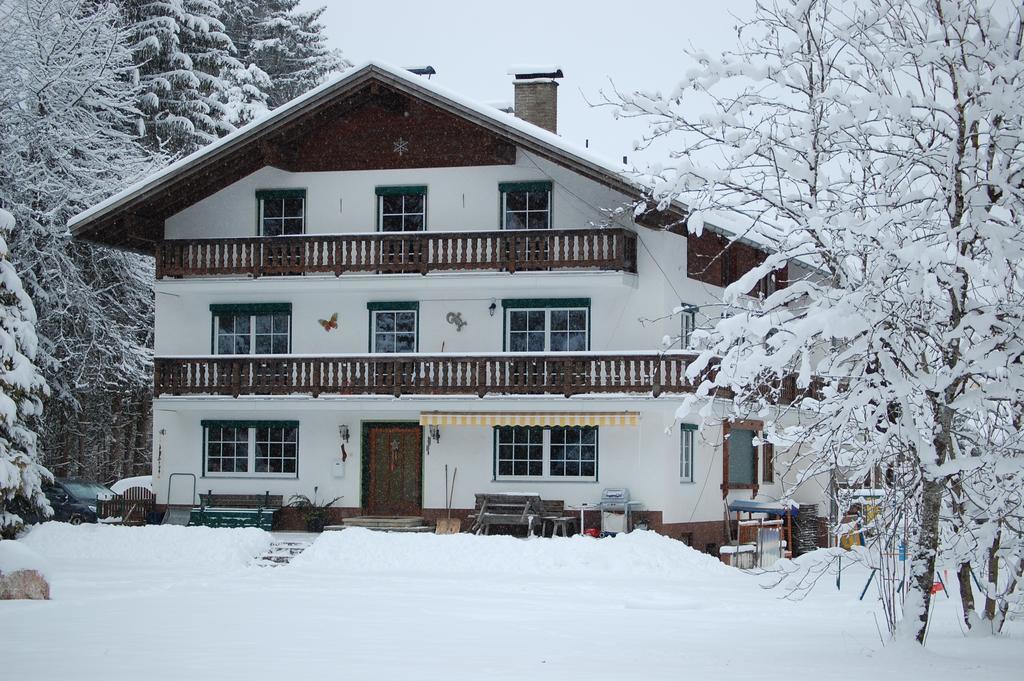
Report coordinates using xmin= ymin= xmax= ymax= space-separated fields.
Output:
xmin=0 ymin=523 xmax=1024 ymax=681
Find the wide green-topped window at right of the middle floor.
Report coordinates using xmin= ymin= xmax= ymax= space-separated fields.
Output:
xmin=502 ymin=298 xmax=590 ymax=352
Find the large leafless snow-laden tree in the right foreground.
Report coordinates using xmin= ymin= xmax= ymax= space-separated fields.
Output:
xmin=616 ymin=0 xmax=1024 ymax=642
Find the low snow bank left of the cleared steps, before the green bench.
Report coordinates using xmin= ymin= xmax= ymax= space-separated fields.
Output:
xmin=19 ymin=522 xmax=270 ymax=567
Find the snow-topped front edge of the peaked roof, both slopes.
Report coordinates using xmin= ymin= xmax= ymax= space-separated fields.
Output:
xmin=68 ymin=60 xmax=663 ymax=245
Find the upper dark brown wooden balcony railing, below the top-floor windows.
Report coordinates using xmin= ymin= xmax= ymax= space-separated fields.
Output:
xmin=156 ymin=227 xmax=637 ymax=279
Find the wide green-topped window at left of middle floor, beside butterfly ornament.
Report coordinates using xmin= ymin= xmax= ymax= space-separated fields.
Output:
xmin=210 ymin=303 xmax=292 ymax=354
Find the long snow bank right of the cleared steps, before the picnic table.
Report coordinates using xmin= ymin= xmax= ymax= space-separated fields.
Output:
xmin=292 ymin=528 xmax=740 ymax=578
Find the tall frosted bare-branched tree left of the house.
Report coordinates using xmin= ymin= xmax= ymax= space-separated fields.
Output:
xmin=0 ymin=0 xmax=157 ymax=489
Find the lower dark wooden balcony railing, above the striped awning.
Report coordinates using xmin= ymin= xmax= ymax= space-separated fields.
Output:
xmin=154 ymin=352 xmax=694 ymax=397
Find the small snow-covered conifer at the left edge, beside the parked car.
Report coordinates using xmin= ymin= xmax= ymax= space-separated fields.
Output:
xmin=0 ymin=209 xmax=51 ymax=539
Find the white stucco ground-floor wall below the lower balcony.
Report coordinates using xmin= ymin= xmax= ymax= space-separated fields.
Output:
xmin=154 ymin=397 xmax=820 ymax=522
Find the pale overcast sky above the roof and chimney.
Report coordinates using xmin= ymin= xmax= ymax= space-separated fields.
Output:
xmin=301 ymin=0 xmax=753 ymax=165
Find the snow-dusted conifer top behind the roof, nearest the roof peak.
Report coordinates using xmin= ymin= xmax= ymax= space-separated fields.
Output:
xmin=221 ymin=0 xmax=351 ymax=109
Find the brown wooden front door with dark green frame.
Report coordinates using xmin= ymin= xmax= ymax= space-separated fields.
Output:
xmin=362 ymin=423 xmax=423 ymax=515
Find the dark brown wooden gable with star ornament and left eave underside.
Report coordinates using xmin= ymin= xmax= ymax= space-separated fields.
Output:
xmin=76 ymin=79 xmax=516 ymax=253
